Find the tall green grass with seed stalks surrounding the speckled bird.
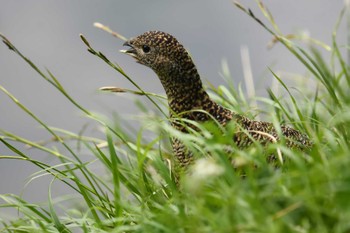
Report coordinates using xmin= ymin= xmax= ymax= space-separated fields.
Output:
xmin=0 ymin=1 xmax=350 ymax=232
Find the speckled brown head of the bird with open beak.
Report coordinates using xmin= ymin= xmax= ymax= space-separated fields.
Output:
xmin=122 ymin=31 xmax=193 ymax=76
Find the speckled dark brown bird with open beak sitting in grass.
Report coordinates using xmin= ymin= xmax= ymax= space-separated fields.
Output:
xmin=121 ymin=31 xmax=312 ymax=167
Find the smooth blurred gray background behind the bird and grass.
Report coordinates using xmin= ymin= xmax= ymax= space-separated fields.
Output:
xmin=0 ymin=0 xmax=346 ymax=217
